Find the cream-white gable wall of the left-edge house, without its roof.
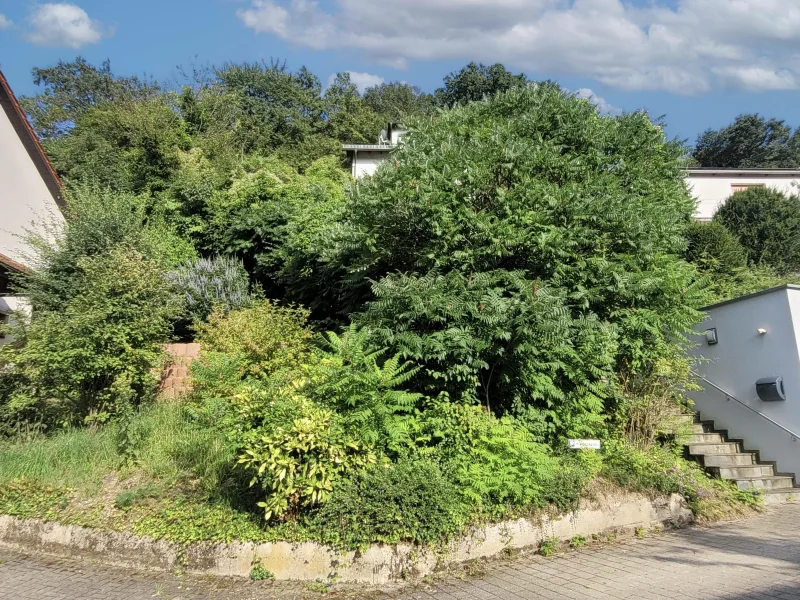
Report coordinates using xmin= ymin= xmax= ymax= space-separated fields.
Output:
xmin=0 ymin=102 xmax=64 ymax=264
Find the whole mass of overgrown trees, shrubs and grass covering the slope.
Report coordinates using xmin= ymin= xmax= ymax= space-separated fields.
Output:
xmin=0 ymin=60 xmax=784 ymax=552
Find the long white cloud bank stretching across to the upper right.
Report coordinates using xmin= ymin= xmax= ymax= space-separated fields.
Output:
xmin=237 ymin=0 xmax=800 ymax=94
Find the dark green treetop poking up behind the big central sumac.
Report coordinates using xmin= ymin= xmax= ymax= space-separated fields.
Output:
xmin=435 ymin=62 xmax=528 ymax=108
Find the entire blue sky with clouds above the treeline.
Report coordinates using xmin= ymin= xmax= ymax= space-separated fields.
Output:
xmin=0 ymin=0 xmax=800 ymax=141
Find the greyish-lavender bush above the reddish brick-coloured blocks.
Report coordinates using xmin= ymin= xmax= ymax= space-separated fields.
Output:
xmin=169 ymin=256 xmax=253 ymax=323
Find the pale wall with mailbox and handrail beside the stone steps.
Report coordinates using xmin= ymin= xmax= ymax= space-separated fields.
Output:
xmin=690 ymin=288 xmax=800 ymax=477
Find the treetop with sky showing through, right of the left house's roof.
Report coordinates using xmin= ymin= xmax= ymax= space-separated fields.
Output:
xmin=20 ymin=56 xmax=161 ymax=139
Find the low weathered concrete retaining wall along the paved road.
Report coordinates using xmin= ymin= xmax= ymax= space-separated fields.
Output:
xmin=0 ymin=494 xmax=694 ymax=585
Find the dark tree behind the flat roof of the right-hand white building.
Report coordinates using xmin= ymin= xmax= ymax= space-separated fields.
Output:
xmin=693 ymin=114 xmax=800 ymax=169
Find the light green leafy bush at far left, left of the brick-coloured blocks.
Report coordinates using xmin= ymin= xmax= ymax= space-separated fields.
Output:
xmin=0 ymin=246 xmax=180 ymax=425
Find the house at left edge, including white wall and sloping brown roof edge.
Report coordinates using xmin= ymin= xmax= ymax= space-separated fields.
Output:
xmin=0 ymin=72 xmax=64 ymax=343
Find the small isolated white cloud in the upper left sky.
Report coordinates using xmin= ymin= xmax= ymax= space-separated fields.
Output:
xmin=27 ymin=3 xmax=110 ymax=48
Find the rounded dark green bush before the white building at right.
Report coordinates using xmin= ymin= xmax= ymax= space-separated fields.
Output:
xmin=714 ymin=187 xmax=800 ymax=274
